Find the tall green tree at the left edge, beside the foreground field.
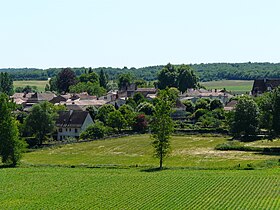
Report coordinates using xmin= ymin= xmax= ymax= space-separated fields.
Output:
xmin=0 ymin=94 xmax=25 ymax=166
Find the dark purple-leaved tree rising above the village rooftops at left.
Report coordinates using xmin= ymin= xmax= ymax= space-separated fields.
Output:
xmin=56 ymin=68 xmax=77 ymax=93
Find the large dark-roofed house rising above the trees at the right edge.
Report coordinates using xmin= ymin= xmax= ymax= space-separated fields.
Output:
xmin=252 ymin=79 xmax=280 ymax=96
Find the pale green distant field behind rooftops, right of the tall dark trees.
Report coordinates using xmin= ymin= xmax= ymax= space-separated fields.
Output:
xmin=201 ymin=80 xmax=254 ymax=94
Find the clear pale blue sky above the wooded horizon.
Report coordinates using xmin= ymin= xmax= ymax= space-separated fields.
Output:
xmin=0 ymin=0 xmax=280 ymax=68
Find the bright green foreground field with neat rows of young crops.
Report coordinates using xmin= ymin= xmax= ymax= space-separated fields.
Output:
xmin=0 ymin=167 xmax=280 ymax=209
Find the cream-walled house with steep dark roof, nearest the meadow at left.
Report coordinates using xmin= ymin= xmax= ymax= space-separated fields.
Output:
xmin=56 ymin=110 xmax=93 ymax=141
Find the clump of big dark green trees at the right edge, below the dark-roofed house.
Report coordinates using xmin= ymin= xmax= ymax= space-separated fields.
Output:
xmin=229 ymin=88 xmax=280 ymax=138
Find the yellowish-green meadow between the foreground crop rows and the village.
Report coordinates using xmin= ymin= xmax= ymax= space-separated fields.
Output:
xmin=22 ymin=135 xmax=280 ymax=169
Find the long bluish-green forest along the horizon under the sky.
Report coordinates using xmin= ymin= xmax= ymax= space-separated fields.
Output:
xmin=0 ymin=62 xmax=280 ymax=81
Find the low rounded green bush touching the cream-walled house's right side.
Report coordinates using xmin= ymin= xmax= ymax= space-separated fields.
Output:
xmin=80 ymin=121 xmax=107 ymax=139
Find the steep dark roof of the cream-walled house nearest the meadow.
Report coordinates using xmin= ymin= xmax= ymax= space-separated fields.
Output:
xmin=56 ymin=110 xmax=88 ymax=128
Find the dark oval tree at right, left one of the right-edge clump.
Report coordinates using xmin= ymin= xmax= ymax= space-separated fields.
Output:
xmin=231 ymin=96 xmax=259 ymax=138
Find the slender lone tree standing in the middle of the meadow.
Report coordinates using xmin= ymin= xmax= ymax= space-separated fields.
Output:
xmin=151 ymin=90 xmax=174 ymax=170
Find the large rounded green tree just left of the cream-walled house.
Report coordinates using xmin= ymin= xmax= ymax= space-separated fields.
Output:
xmin=25 ymin=102 xmax=57 ymax=145
